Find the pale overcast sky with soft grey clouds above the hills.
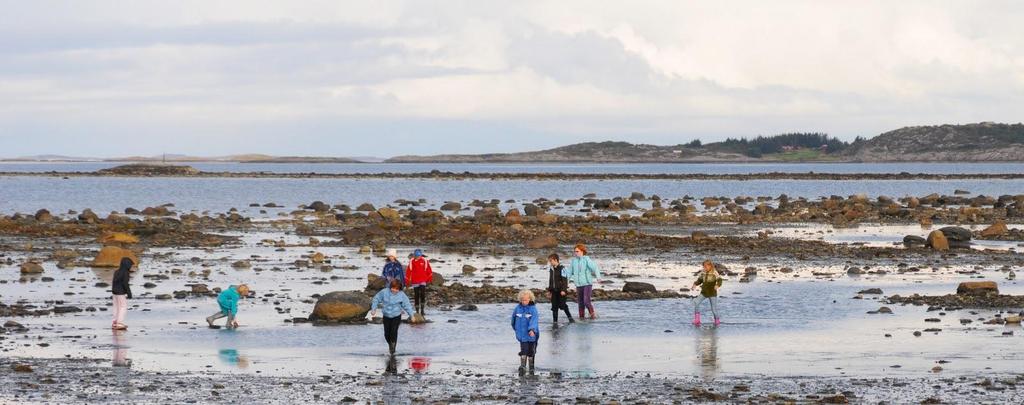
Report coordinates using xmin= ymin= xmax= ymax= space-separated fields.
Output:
xmin=0 ymin=0 xmax=1024 ymax=158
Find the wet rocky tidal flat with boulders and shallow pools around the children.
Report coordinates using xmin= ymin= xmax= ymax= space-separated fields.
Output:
xmin=0 ymin=179 xmax=1024 ymax=403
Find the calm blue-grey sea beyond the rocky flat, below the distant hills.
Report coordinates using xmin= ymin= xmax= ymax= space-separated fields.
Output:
xmin=0 ymin=164 xmax=1024 ymax=215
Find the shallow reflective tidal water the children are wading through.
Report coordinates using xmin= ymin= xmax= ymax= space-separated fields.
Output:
xmin=0 ymin=242 xmax=1024 ymax=378
